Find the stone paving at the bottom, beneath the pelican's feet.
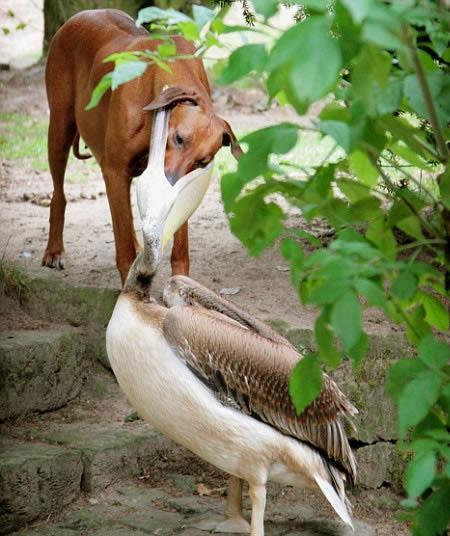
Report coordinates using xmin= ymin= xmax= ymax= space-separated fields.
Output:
xmin=9 ymin=482 xmax=376 ymax=536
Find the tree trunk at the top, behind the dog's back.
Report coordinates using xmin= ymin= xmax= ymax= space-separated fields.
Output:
xmin=44 ymin=0 xmax=199 ymax=54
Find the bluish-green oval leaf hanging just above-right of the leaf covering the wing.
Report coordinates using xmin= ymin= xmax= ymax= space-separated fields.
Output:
xmin=331 ymin=292 xmax=362 ymax=351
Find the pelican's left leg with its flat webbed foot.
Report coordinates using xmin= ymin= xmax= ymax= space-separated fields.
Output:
xmin=195 ymin=476 xmax=250 ymax=534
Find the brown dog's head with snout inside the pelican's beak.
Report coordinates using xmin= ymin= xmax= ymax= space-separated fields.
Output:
xmin=144 ymin=87 xmax=242 ymax=184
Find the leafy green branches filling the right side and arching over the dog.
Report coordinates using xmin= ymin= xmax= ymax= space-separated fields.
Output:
xmin=90 ymin=0 xmax=450 ymax=536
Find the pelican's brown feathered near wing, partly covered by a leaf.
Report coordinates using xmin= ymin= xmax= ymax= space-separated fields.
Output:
xmin=163 ymin=305 xmax=356 ymax=480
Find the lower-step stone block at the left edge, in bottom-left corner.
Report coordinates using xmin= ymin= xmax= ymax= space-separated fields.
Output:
xmin=0 ymin=440 xmax=83 ymax=534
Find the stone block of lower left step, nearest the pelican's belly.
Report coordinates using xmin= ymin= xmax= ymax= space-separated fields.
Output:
xmin=34 ymin=423 xmax=174 ymax=492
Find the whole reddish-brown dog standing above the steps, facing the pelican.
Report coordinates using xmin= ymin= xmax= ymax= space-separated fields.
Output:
xmin=42 ymin=9 xmax=240 ymax=284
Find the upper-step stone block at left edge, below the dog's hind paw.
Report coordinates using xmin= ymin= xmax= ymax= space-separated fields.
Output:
xmin=0 ymin=327 xmax=87 ymax=420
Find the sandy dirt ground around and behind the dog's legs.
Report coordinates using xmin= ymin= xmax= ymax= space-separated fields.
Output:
xmin=0 ymin=65 xmax=394 ymax=331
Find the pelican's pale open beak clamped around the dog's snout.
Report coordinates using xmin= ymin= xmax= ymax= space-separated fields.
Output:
xmin=137 ymin=109 xmax=214 ymax=265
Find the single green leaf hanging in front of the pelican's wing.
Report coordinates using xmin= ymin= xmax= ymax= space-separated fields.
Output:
xmin=289 ymin=354 xmax=322 ymax=415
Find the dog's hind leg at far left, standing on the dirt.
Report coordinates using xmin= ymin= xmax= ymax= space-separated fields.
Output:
xmin=42 ymin=110 xmax=77 ymax=269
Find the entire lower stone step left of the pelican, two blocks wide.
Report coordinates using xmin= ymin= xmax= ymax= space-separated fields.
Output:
xmin=0 ymin=422 xmax=174 ymax=534
